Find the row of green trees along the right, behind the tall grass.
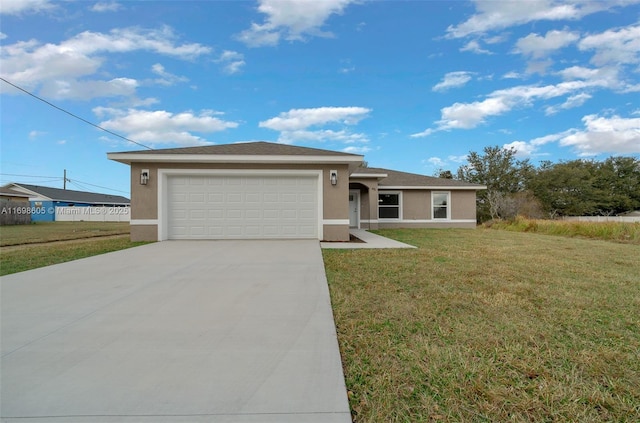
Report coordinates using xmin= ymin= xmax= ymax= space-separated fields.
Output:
xmin=438 ymin=146 xmax=640 ymax=222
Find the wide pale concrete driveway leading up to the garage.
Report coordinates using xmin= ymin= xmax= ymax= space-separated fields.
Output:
xmin=0 ymin=241 xmax=351 ymax=422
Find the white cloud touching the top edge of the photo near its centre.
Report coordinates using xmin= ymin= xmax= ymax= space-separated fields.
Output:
xmin=237 ymin=0 xmax=358 ymax=47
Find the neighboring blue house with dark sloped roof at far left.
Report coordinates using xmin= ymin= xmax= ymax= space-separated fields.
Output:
xmin=3 ymin=183 xmax=130 ymax=222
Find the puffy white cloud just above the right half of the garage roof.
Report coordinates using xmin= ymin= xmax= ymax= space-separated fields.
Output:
xmin=258 ymin=107 xmax=371 ymax=144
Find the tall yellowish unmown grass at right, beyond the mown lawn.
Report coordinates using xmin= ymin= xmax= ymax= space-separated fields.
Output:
xmin=485 ymin=216 xmax=640 ymax=245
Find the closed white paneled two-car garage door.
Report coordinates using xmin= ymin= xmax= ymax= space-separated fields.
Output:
xmin=167 ymin=175 xmax=318 ymax=239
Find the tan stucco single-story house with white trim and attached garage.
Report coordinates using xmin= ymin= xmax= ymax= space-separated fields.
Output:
xmin=107 ymin=142 xmax=486 ymax=241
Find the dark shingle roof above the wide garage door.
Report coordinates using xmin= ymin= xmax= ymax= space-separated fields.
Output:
xmin=115 ymin=141 xmax=359 ymax=157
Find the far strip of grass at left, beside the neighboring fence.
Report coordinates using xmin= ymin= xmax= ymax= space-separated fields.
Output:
xmin=0 ymin=222 xmax=129 ymax=247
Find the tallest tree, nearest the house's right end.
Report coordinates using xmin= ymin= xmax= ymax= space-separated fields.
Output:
xmin=457 ymin=146 xmax=534 ymax=221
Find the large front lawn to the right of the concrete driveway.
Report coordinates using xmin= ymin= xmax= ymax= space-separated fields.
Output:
xmin=323 ymin=229 xmax=640 ymax=422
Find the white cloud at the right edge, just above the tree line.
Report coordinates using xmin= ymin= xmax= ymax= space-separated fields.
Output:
xmin=559 ymin=115 xmax=640 ymax=156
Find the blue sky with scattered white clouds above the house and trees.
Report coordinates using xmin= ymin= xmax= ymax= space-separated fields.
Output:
xmin=0 ymin=0 xmax=640 ymax=195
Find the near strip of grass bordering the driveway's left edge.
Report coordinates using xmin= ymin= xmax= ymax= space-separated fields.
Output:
xmin=0 ymin=236 xmax=145 ymax=276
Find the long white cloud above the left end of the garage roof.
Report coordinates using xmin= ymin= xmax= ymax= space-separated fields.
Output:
xmin=93 ymin=107 xmax=238 ymax=146
